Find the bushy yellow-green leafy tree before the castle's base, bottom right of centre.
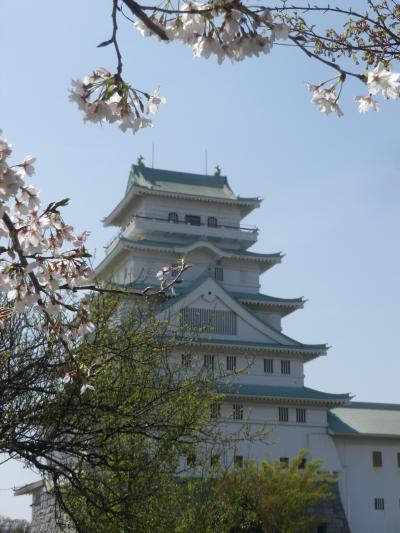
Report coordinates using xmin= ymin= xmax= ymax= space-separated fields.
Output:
xmin=209 ymin=452 xmax=336 ymax=533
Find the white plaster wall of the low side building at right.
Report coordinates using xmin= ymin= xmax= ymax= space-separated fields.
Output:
xmin=334 ymin=436 xmax=400 ymax=533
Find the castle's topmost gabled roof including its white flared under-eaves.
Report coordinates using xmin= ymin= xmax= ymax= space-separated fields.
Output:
xmin=103 ymin=165 xmax=261 ymax=226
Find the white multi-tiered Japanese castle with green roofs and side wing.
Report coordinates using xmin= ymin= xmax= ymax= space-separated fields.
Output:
xmin=16 ymin=164 xmax=400 ymax=533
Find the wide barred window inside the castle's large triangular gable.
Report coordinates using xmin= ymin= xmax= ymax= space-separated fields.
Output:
xmin=180 ymin=307 xmax=237 ymax=335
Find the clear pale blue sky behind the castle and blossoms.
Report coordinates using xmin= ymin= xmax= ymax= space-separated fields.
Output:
xmin=0 ymin=0 xmax=400 ymax=519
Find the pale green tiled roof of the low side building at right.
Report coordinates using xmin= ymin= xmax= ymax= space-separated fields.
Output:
xmin=328 ymin=402 xmax=400 ymax=437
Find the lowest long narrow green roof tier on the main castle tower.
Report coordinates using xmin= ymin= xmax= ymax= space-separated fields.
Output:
xmin=218 ymin=383 xmax=350 ymax=403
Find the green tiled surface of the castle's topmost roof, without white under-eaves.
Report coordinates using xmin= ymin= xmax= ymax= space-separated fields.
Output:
xmin=126 ymin=165 xmax=259 ymax=203
